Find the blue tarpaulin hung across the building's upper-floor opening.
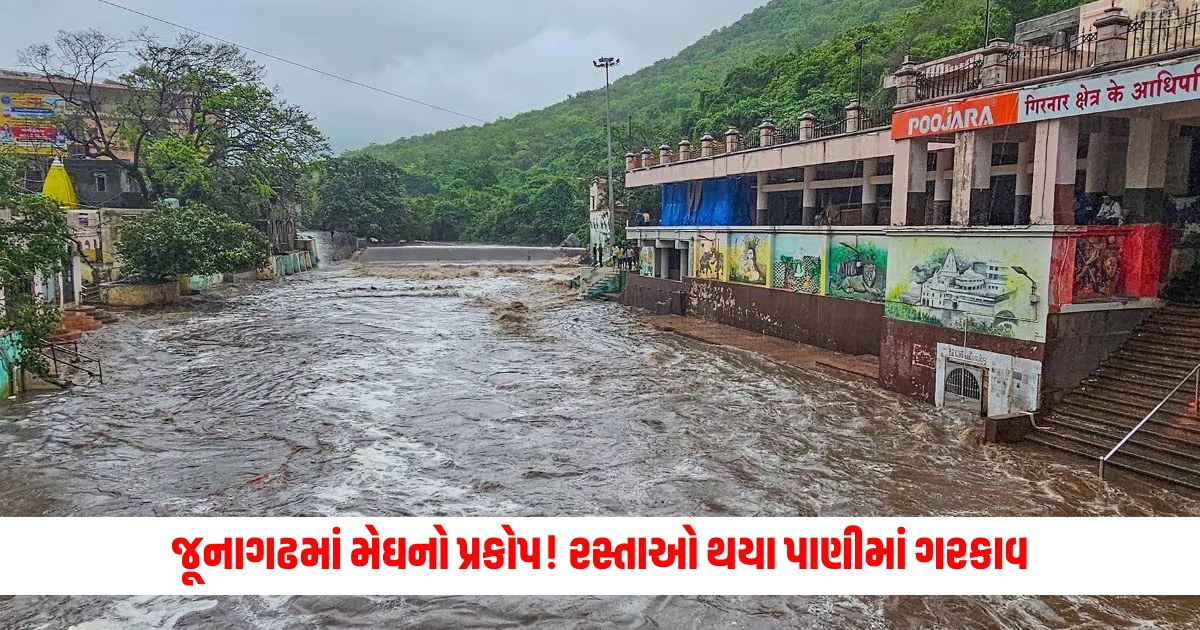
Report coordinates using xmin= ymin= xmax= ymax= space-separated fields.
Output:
xmin=660 ymin=178 xmax=750 ymax=226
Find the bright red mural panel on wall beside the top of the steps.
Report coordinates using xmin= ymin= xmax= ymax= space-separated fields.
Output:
xmin=1050 ymin=224 xmax=1171 ymax=306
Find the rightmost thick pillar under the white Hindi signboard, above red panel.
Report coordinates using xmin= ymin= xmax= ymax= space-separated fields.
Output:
xmin=1123 ymin=118 xmax=1171 ymax=223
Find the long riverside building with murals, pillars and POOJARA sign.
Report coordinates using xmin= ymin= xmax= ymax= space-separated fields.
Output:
xmin=625 ymin=0 xmax=1200 ymax=416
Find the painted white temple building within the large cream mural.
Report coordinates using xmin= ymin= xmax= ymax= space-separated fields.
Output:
xmin=920 ymin=250 xmax=1013 ymax=317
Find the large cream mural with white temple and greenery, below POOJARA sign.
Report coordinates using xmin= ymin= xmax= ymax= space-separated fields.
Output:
xmin=884 ymin=236 xmax=1051 ymax=342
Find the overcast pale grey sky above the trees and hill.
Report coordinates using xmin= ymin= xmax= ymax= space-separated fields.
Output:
xmin=0 ymin=0 xmax=767 ymax=150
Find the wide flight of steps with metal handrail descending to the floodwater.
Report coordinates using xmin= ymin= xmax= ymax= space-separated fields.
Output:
xmin=1027 ymin=304 xmax=1200 ymax=491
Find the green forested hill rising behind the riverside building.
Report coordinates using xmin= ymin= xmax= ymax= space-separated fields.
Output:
xmin=345 ymin=0 xmax=1079 ymax=242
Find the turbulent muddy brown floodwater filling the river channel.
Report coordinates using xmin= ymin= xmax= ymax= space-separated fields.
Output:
xmin=0 ymin=248 xmax=1200 ymax=629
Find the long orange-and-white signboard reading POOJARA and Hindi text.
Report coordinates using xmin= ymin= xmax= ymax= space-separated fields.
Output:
xmin=892 ymin=56 xmax=1200 ymax=140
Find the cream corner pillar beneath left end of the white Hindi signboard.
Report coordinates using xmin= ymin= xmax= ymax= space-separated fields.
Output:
xmin=1030 ymin=118 xmax=1079 ymax=226
